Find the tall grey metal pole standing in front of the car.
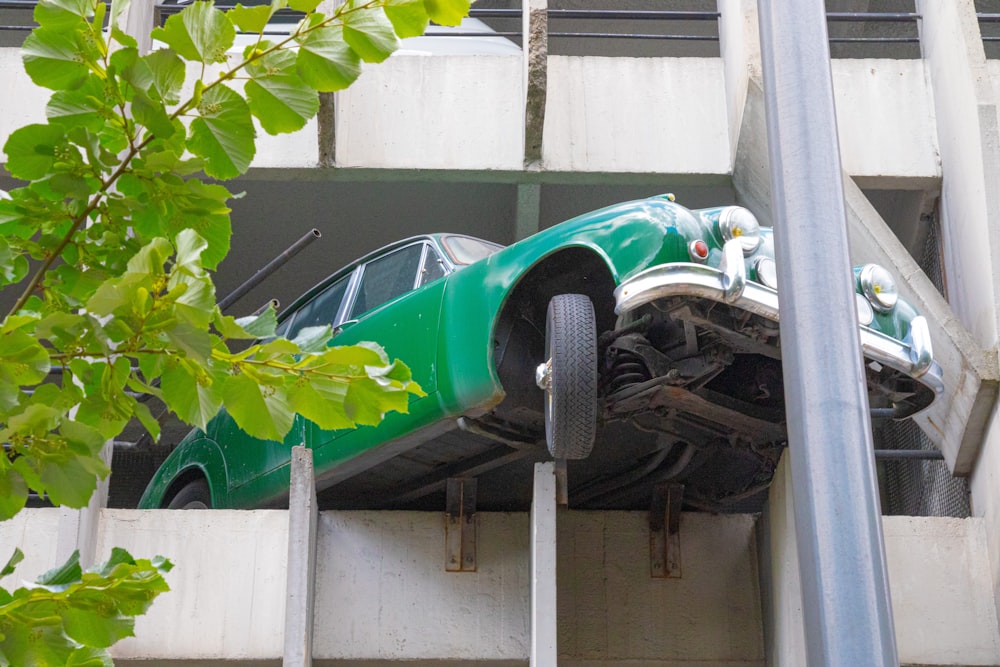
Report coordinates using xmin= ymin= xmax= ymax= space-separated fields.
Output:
xmin=758 ymin=0 xmax=899 ymax=667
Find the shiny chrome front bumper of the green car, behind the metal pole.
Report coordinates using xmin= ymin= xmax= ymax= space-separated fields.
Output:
xmin=615 ymin=241 xmax=944 ymax=395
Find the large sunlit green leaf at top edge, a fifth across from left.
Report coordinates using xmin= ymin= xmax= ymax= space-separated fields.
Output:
xmin=152 ymin=1 xmax=236 ymax=64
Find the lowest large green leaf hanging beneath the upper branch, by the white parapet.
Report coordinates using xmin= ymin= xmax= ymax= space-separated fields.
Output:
xmin=188 ymin=85 xmax=256 ymax=179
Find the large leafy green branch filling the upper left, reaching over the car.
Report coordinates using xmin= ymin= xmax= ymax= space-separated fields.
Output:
xmin=0 ymin=0 xmax=468 ymax=520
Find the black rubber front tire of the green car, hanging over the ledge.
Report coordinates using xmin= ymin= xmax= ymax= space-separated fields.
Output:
xmin=545 ymin=294 xmax=597 ymax=459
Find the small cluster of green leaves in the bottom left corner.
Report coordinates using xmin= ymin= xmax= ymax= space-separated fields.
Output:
xmin=0 ymin=548 xmax=173 ymax=667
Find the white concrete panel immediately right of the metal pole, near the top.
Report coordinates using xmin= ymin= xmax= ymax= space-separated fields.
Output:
xmin=831 ymin=58 xmax=941 ymax=188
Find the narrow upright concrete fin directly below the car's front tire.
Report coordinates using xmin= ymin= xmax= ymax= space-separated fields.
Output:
xmin=530 ymin=461 xmax=558 ymax=667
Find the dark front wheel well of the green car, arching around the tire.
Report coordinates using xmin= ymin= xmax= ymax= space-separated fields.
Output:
xmin=494 ymin=248 xmax=615 ymax=422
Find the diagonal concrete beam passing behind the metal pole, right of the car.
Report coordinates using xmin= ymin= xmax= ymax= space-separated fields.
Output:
xmin=733 ymin=77 xmax=1000 ymax=475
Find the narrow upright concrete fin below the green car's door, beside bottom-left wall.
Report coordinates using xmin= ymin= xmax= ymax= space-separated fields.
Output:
xmin=282 ymin=445 xmax=319 ymax=667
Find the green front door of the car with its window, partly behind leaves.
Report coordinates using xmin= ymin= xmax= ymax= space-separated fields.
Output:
xmin=306 ymin=241 xmax=447 ymax=466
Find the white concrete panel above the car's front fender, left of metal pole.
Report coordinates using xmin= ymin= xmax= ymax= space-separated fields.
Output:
xmin=542 ymin=56 xmax=730 ymax=174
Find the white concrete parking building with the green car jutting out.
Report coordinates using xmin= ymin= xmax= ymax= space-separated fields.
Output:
xmin=0 ymin=0 xmax=1000 ymax=667
